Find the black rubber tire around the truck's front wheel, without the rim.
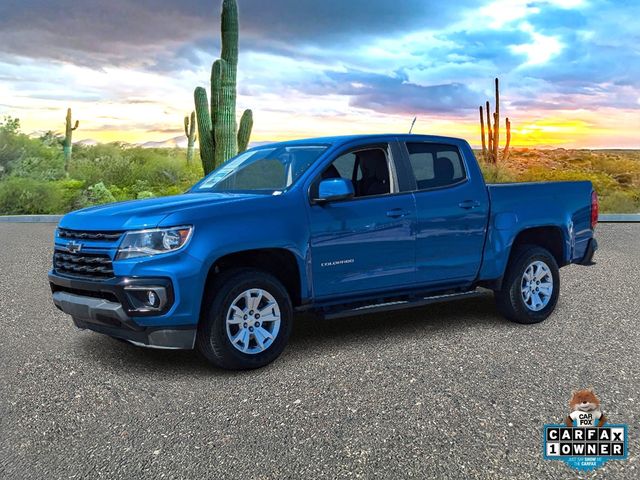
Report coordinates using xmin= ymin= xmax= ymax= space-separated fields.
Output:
xmin=196 ymin=269 xmax=293 ymax=370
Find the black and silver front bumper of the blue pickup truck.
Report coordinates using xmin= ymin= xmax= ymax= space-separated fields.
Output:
xmin=49 ymin=272 xmax=196 ymax=349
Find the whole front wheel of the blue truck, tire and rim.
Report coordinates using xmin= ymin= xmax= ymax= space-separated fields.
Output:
xmin=196 ymin=269 xmax=293 ymax=370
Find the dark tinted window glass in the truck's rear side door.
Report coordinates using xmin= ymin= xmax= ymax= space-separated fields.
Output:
xmin=407 ymin=143 xmax=466 ymax=190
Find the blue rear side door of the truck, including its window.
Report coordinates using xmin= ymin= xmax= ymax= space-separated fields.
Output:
xmin=404 ymin=141 xmax=489 ymax=286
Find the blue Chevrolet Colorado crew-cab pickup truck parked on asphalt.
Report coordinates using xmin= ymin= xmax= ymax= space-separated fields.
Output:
xmin=49 ymin=135 xmax=598 ymax=369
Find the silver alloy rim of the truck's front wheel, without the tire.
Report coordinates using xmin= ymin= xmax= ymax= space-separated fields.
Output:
xmin=226 ymin=288 xmax=281 ymax=355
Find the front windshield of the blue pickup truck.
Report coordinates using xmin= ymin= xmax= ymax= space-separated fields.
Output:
xmin=191 ymin=145 xmax=328 ymax=194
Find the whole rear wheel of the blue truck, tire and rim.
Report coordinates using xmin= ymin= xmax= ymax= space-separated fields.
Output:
xmin=494 ymin=245 xmax=560 ymax=324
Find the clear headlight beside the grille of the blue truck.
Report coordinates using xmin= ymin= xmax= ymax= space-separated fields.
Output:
xmin=116 ymin=227 xmax=193 ymax=260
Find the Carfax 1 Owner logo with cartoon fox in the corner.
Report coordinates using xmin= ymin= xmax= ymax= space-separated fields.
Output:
xmin=543 ymin=388 xmax=628 ymax=470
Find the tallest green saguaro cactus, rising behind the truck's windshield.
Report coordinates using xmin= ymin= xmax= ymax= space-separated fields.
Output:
xmin=194 ymin=0 xmax=253 ymax=175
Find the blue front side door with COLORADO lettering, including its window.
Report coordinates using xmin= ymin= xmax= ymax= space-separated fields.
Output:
xmin=310 ymin=144 xmax=416 ymax=299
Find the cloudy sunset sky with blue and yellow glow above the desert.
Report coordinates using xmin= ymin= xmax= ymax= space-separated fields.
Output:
xmin=0 ymin=0 xmax=640 ymax=148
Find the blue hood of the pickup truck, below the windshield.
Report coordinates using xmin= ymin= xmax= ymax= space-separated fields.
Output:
xmin=60 ymin=193 xmax=261 ymax=230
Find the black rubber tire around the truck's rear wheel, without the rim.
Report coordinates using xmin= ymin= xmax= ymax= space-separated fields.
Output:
xmin=494 ymin=245 xmax=560 ymax=324
